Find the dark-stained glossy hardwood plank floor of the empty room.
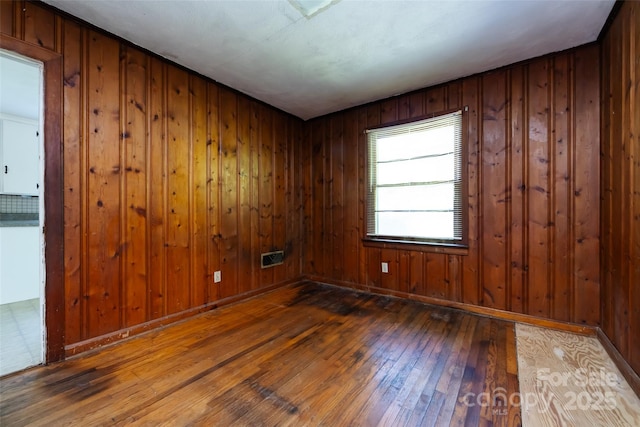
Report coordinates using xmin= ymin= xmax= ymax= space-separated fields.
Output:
xmin=0 ymin=283 xmax=520 ymax=426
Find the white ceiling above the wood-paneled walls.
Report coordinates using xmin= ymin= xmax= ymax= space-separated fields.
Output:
xmin=45 ymin=0 xmax=614 ymax=119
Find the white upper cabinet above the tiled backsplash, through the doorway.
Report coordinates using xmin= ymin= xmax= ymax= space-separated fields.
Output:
xmin=0 ymin=118 xmax=40 ymax=196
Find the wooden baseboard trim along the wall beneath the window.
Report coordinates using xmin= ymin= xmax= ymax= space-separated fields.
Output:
xmin=305 ymin=275 xmax=598 ymax=336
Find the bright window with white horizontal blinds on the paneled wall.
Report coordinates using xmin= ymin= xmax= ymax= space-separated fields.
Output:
xmin=367 ymin=111 xmax=466 ymax=245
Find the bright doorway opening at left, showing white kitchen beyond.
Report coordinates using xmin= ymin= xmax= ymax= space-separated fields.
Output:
xmin=0 ymin=50 xmax=46 ymax=375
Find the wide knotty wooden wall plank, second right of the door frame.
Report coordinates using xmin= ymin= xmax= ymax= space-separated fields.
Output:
xmin=86 ymin=31 xmax=122 ymax=336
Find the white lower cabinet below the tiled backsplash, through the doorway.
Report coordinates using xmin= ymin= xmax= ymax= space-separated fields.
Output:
xmin=0 ymin=227 xmax=41 ymax=304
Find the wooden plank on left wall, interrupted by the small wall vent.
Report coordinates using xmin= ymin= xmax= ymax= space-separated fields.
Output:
xmin=259 ymin=108 xmax=275 ymax=286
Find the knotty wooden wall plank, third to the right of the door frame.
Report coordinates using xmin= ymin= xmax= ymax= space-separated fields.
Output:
xmin=120 ymin=47 xmax=148 ymax=326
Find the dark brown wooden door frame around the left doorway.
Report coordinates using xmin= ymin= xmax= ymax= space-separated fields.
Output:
xmin=0 ymin=34 xmax=65 ymax=363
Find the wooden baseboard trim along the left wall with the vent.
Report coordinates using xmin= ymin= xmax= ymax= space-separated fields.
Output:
xmin=64 ymin=277 xmax=301 ymax=358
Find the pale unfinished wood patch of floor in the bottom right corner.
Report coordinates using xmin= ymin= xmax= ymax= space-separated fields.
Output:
xmin=516 ymin=324 xmax=640 ymax=427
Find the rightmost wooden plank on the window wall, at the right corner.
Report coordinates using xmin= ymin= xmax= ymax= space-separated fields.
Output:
xmin=573 ymin=45 xmax=600 ymax=325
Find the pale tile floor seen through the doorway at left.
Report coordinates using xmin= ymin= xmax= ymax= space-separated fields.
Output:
xmin=0 ymin=298 xmax=42 ymax=376
